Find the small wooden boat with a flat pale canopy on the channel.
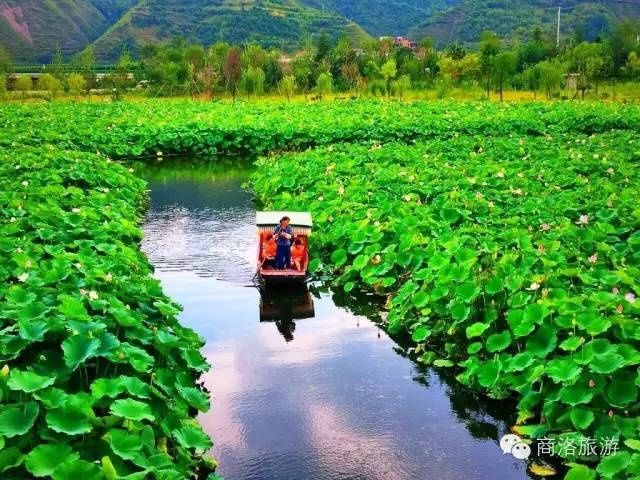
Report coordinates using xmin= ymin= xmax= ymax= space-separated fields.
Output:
xmin=256 ymin=212 xmax=313 ymax=285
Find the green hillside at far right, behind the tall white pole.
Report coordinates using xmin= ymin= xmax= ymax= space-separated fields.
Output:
xmin=410 ymin=0 xmax=640 ymax=44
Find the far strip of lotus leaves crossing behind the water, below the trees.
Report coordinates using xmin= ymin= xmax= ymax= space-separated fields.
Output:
xmin=0 ymin=100 xmax=640 ymax=158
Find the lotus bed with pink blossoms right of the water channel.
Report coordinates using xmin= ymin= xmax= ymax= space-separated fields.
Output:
xmin=252 ymin=131 xmax=640 ymax=480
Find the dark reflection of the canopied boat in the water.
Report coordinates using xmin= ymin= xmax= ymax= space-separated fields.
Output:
xmin=260 ymin=285 xmax=315 ymax=342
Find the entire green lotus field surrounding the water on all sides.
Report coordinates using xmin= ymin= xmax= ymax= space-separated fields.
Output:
xmin=0 ymin=100 xmax=640 ymax=480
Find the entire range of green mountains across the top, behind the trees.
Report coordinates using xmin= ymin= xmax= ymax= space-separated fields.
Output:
xmin=0 ymin=0 xmax=640 ymax=62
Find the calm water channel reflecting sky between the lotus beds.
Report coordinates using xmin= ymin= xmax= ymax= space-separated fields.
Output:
xmin=143 ymin=160 xmax=529 ymax=480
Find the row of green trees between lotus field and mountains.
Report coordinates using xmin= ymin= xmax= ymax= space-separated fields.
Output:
xmin=0 ymin=22 xmax=640 ymax=99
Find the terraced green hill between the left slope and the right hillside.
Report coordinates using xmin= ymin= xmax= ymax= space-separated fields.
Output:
xmin=95 ymin=0 xmax=366 ymax=58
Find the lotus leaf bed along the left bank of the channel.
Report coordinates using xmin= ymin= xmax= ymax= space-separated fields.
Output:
xmin=0 ymin=147 xmax=214 ymax=480
